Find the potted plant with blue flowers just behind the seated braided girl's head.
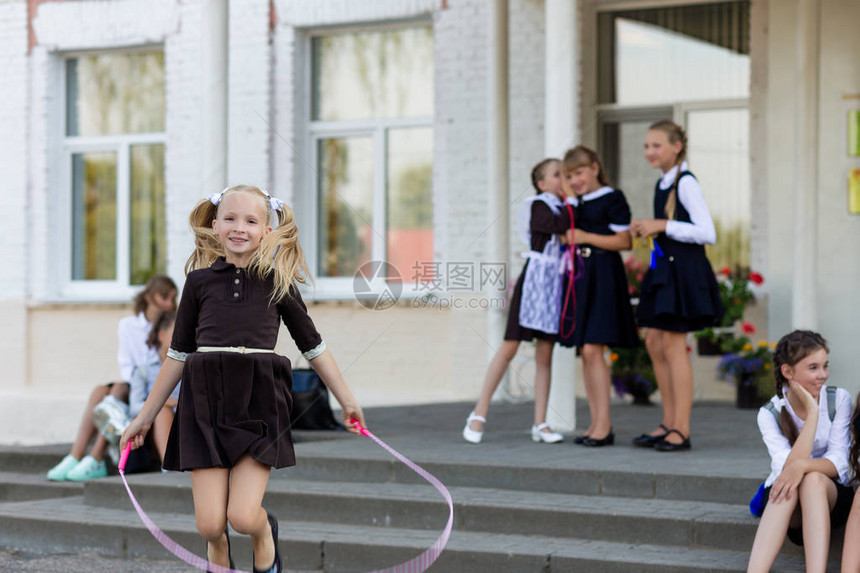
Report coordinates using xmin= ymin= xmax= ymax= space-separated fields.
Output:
xmin=717 ymin=330 xmax=775 ymax=408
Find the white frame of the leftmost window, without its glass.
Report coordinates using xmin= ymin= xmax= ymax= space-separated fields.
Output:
xmin=54 ymin=45 xmax=167 ymax=302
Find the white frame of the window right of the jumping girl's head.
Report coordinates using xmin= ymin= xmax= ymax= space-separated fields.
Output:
xmin=302 ymin=19 xmax=436 ymax=300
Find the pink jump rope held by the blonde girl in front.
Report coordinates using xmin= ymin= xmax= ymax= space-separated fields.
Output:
xmin=118 ymin=420 xmax=454 ymax=573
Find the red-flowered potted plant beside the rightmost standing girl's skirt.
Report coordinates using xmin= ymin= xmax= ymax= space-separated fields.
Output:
xmin=695 ymin=267 xmax=764 ymax=356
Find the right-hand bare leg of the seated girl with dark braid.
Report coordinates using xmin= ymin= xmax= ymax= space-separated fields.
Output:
xmin=798 ymin=472 xmax=836 ymax=573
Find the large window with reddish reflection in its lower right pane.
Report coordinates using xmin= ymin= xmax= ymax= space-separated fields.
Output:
xmin=309 ymin=26 xmax=433 ymax=281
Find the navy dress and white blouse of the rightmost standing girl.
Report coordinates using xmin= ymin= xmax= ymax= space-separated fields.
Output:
xmin=637 ymin=162 xmax=723 ymax=332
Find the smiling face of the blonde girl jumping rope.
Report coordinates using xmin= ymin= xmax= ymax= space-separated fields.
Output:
xmin=212 ymin=191 xmax=272 ymax=267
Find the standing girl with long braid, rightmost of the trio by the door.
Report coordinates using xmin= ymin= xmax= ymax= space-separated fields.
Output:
xmin=630 ymin=121 xmax=723 ymax=452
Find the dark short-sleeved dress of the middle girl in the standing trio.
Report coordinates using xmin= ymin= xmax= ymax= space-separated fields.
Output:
xmin=559 ymin=187 xmax=639 ymax=347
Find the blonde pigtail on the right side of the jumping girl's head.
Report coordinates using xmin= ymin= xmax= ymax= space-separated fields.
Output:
xmin=251 ymin=205 xmax=310 ymax=303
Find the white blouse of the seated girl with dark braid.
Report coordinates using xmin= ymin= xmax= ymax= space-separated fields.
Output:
xmin=758 ymin=386 xmax=851 ymax=487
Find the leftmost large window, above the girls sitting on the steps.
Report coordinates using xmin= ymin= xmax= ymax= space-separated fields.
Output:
xmin=62 ymin=51 xmax=166 ymax=294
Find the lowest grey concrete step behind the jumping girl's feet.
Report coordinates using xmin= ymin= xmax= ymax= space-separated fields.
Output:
xmin=0 ymin=497 xmax=804 ymax=573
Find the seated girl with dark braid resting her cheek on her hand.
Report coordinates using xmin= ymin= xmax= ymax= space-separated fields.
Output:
xmin=747 ymin=330 xmax=854 ymax=573
